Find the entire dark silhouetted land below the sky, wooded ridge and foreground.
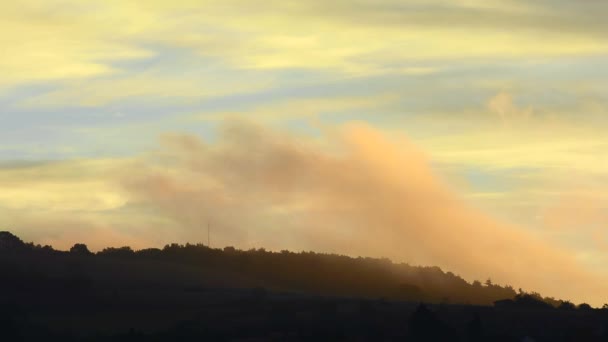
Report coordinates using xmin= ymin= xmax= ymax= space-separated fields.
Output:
xmin=0 ymin=232 xmax=608 ymax=341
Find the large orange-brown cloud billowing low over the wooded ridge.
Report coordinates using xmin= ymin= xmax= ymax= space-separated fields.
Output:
xmin=125 ymin=120 xmax=605 ymax=302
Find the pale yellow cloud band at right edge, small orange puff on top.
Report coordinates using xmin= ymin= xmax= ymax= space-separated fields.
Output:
xmin=404 ymin=91 xmax=608 ymax=175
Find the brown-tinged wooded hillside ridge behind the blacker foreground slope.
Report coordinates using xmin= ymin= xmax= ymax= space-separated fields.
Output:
xmin=0 ymin=232 xmax=516 ymax=305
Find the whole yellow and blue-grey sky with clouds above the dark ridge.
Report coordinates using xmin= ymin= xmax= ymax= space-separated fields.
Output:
xmin=0 ymin=0 xmax=608 ymax=305
